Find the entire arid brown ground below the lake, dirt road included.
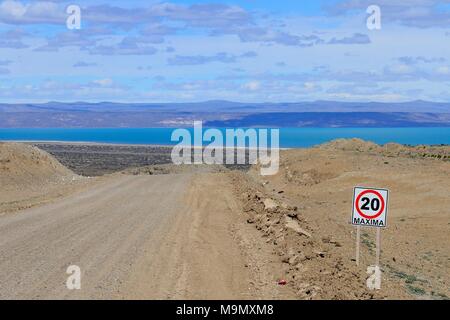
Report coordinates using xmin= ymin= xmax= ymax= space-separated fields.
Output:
xmin=0 ymin=140 xmax=450 ymax=299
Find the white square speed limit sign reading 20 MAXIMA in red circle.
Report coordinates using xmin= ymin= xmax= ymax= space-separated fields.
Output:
xmin=352 ymin=187 xmax=389 ymax=228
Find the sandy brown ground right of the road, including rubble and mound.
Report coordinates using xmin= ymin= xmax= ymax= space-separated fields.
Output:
xmin=234 ymin=140 xmax=450 ymax=299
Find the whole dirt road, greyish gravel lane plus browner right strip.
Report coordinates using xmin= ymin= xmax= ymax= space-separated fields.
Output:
xmin=0 ymin=174 xmax=292 ymax=299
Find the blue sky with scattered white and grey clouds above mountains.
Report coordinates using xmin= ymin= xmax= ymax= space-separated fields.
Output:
xmin=0 ymin=0 xmax=450 ymax=103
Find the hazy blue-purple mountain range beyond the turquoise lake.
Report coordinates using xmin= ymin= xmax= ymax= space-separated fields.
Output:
xmin=0 ymin=101 xmax=450 ymax=128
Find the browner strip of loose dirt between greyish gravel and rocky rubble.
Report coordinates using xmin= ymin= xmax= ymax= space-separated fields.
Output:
xmin=123 ymin=173 xmax=294 ymax=299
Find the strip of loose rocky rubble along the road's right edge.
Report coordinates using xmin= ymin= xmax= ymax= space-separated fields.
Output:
xmin=230 ymin=171 xmax=377 ymax=299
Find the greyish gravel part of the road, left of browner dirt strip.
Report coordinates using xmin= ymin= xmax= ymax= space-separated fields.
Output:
xmin=0 ymin=175 xmax=191 ymax=299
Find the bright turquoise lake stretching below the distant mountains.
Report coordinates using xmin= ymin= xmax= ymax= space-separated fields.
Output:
xmin=0 ymin=127 xmax=450 ymax=148
